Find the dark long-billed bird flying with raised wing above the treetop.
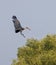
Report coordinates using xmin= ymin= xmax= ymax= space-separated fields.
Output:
xmin=12 ymin=15 xmax=31 ymax=38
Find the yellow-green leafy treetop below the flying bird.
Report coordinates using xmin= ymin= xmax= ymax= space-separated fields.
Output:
xmin=12 ymin=35 xmax=56 ymax=65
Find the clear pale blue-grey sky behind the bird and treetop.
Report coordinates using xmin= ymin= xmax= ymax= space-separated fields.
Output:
xmin=0 ymin=0 xmax=56 ymax=65
